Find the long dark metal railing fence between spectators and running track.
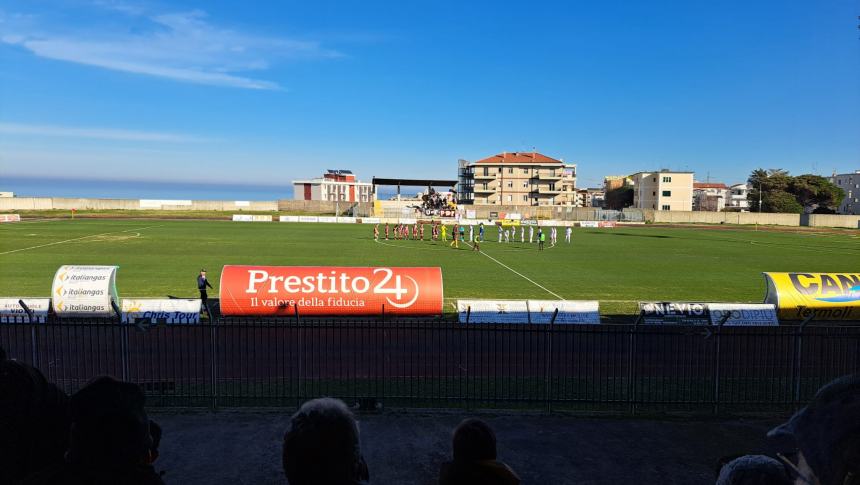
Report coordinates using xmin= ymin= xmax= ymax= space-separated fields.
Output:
xmin=0 ymin=319 xmax=860 ymax=414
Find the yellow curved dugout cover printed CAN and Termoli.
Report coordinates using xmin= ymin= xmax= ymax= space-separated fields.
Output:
xmin=764 ymin=273 xmax=860 ymax=320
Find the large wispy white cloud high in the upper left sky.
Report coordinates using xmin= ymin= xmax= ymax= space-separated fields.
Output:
xmin=0 ymin=8 xmax=341 ymax=89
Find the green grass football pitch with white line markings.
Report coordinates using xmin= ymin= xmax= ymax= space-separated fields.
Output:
xmin=0 ymin=219 xmax=860 ymax=314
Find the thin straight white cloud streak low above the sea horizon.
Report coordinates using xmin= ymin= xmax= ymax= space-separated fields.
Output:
xmin=0 ymin=123 xmax=208 ymax=143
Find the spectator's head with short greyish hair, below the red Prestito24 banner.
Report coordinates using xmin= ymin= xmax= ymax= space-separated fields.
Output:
xmin=283 ymin=398 xmax=369 ymax=485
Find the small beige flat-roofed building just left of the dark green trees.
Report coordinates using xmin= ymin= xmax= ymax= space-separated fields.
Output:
xmin=630 ymin=171 xmax=693 ymax=211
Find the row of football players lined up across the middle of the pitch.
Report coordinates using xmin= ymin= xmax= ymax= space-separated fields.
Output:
xmin=373 ymin=221 xmax=573 ymax=251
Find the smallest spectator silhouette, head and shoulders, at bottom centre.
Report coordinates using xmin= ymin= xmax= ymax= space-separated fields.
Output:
xmin=439 ymin=418 xmax=520 ymax=485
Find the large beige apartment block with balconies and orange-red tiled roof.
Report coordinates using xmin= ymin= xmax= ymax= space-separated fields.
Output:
xmin=459 ymin=152 xmax=577 ymax=206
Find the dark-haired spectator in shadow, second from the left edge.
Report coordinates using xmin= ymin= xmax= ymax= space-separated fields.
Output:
xmin=24 ymin=376 xmax=164 ymax=485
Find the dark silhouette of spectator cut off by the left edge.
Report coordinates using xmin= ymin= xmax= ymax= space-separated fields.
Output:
xmin=0 ymin=349 xmax=69 ymax=484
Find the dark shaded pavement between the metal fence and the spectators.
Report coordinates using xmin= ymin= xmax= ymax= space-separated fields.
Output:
xmin=152 ymin=409 xmax=779 ymax=485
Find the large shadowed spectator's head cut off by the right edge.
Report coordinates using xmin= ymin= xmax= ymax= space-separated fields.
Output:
xmin=768 ymin=375 xmax=860 ymax=485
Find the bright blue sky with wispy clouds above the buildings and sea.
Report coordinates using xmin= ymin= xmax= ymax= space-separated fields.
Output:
xmin=0 ymin=0 xmax=860 ymax=186
